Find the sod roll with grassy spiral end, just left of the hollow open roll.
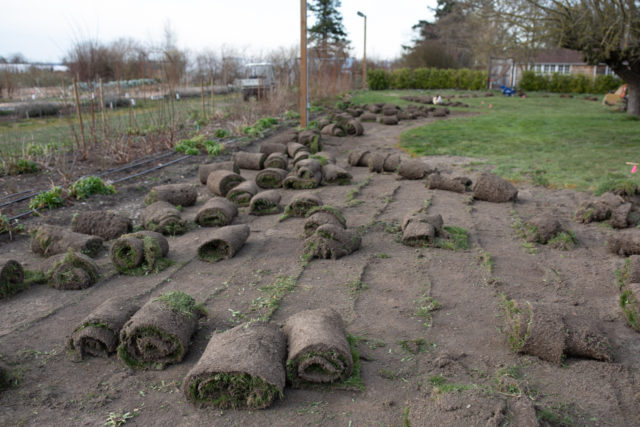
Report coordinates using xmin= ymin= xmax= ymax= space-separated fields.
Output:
xmin=109 ymin=231 xmax=170 ymax=276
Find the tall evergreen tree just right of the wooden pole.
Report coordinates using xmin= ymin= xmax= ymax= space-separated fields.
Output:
xmin=308 ymin=0 xmax=349 ymax=58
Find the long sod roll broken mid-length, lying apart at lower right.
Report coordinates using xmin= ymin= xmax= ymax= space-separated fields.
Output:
xmin=505 ymin=300 xmax=611 ymax=365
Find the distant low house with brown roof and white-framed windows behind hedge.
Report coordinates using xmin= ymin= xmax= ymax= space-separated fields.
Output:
xmin=491 ymin=48 xmax=614 ymax=87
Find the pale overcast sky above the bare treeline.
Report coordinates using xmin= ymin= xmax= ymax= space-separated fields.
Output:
xmin=0 ymin=0 xmax=436 ymax=62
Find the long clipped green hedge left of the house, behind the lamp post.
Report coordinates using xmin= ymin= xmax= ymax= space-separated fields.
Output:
xmin=367 ymin=68 xmax=487 ymax=90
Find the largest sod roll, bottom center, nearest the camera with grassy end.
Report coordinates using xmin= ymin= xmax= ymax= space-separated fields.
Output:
xmin=182 ymin=323 xmax=287 ymax=409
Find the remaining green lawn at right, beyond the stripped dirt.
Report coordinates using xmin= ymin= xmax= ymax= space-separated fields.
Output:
xmin=352 ymin=90 xmax=640 ymax=193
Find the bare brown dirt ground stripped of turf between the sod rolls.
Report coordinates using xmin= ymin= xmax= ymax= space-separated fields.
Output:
xmin=0 ymin=114 xmax=640 ymax=426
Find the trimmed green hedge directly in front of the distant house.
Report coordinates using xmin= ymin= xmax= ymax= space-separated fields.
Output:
xmin=519 ymin=71 xmax=622 ymax=93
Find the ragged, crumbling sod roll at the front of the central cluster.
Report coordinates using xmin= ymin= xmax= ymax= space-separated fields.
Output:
xmin=305 ymin=224 xmax=362 ymax=259
